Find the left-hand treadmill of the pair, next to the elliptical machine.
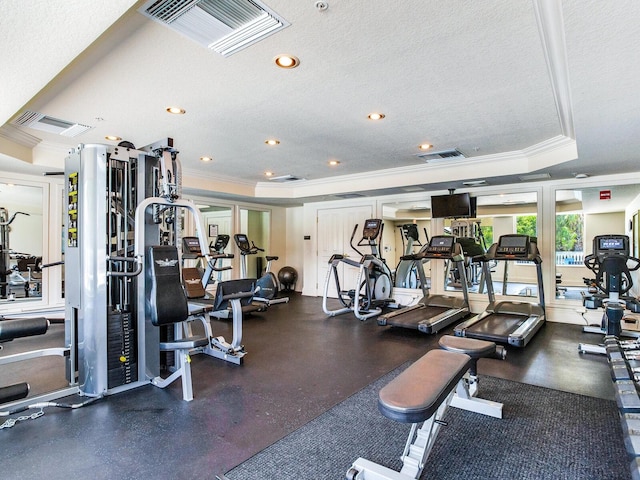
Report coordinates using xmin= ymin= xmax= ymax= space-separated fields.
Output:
xmin=378 ymin=235 xmax=469 ymax=333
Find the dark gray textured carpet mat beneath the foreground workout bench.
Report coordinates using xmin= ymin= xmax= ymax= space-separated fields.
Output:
xmin=225 ymin=365 xmax=631 ymax=480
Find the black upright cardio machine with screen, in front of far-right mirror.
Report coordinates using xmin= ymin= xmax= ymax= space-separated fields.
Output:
xmin=578 ymin=235 xmax=640 ymax=354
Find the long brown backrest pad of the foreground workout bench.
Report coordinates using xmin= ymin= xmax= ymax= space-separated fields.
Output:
xmin=378 ymin=350 xmax=472 ymax=423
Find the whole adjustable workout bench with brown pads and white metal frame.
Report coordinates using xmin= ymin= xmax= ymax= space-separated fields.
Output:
xmin=346 ymin=335 xmax=504 ymax=480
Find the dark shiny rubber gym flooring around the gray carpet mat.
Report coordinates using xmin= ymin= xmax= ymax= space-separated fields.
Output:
xmin=0 ymin=295 xmax=613 ymax=479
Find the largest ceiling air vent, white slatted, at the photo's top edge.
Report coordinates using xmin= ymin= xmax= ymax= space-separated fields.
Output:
xmin=139 ymin=0 xmax=289 ymax=57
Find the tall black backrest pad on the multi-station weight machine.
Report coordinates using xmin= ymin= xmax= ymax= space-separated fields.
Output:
xmin=147 ymin=245 xmax=189 ymax=326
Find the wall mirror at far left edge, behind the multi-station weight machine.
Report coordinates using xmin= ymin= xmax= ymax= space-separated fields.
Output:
xmin=0 ymin=181 xmax=44 ymax=306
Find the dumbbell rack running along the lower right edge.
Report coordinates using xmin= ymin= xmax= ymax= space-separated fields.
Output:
xmin=604 ymin=335 xmax=640 ymax=478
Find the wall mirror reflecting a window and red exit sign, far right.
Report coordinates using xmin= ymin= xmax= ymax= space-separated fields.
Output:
xmin=555 ymin=185 xmax=640 ymax=301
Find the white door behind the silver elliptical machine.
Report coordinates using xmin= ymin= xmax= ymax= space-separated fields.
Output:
xmin=317 ymin=205 xmax=373 ymax=298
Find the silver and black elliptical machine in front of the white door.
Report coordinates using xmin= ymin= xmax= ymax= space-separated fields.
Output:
xmin=322 ymin=218 xmax=393 ymax=321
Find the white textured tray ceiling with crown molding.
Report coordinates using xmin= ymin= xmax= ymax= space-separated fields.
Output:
xmin=0 ymin=0 xmax=640 ymax=204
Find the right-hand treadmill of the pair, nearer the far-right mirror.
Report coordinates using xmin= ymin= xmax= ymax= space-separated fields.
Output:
xmin=454 ymin=234 xmax=545 ymax=347
